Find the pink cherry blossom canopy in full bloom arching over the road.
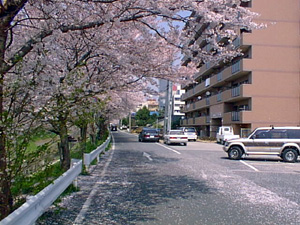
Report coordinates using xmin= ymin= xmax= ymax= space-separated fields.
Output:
xmin=0 ymin=0 xmax=259 ymax=218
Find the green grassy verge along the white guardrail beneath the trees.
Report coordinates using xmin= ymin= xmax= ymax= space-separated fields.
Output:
xmin=11 ymin=131 xmax=109 ymax=209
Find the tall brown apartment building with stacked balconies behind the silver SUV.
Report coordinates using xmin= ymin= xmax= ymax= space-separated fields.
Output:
xmin=181 ymin=0 xmax=300 ymax=137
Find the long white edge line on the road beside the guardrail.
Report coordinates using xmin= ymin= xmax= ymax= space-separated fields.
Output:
xmin=73 ymin=136 xmax=115 ymax=225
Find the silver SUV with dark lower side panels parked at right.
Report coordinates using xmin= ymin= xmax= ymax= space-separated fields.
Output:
xmin=223 ymin=127 xmax=300 ymax=162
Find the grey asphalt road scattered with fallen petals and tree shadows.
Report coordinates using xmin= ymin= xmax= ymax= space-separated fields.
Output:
xmin=37 ymin=131 xmax=300 ymax=225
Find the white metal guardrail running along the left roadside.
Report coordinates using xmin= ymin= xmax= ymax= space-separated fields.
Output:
xmin=0 ymin=135 xmax=111 ymax=225
